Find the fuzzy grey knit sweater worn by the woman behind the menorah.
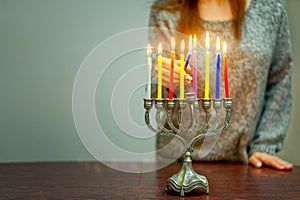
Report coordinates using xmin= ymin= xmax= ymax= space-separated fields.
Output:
xmin=149 ymin=0 xmax=293 ymax=163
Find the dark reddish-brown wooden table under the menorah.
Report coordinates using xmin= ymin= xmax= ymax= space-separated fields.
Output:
xmin=0 ymin=162 xmax=300 ymax=200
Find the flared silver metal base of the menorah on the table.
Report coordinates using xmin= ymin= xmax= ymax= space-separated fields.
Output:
xmin=166 ymin=156 xmax=209 ymax=196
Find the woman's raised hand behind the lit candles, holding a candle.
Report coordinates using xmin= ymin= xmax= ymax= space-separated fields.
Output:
xmin=155 ymin=57 xmax=192 ymax=89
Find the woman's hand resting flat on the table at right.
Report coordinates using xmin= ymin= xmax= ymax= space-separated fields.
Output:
xmin=249 ymin=152 xmax=293 ymax=170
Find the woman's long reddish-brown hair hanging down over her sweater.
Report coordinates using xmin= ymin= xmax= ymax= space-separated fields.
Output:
xmin=157 ymin=0 xmax=246 ymax=40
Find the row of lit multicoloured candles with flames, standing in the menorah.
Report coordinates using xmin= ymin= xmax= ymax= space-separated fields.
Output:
xmin=147 ymin=32 xmax=229 ymax=100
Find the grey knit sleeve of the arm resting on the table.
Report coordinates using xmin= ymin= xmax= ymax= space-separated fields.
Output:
xmin=249 ymin=5 xmax=293 ymax=155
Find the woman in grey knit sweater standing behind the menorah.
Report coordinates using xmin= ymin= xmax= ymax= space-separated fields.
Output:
xmin=150 ymin=0 xmax=293 ymax=170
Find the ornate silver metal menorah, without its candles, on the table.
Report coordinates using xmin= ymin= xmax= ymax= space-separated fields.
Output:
xmin=144 ymin=93 xmax=232 ymax=196
